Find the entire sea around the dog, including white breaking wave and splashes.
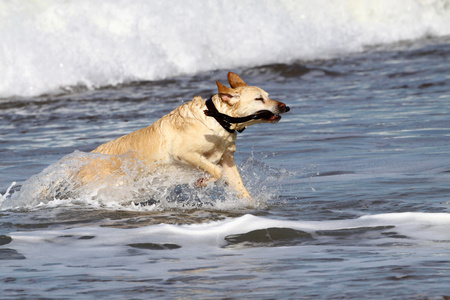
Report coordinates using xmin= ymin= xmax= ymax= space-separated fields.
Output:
xmin=0 ymin=0 xmax=450 ymax=299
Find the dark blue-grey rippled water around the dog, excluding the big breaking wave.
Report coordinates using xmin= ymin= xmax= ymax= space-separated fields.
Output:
xmin=0 ymin=38 xmax=450 ymax=299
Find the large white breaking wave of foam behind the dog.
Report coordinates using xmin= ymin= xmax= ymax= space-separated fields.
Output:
xmin=0 ymin=0 xmax=450 ymax=98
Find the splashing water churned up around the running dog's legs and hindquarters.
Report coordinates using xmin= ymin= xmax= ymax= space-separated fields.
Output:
xmin=0 ymin=151 xmax=286 ymax=211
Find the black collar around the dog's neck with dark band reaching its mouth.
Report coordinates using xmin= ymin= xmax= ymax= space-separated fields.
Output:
xmin=204 ymin=97 xmax=273 ymax=133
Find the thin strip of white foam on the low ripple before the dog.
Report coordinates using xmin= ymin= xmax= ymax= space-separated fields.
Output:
xmin=11 ymin=213 xmax=450 ymax=251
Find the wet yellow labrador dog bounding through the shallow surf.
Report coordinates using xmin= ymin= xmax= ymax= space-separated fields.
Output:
xmin=78 ymin=72 xmax=289 ymax=199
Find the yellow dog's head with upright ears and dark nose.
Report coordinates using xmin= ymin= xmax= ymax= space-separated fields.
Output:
xmin=216 ymin=72 xmax=290 ymax=127
